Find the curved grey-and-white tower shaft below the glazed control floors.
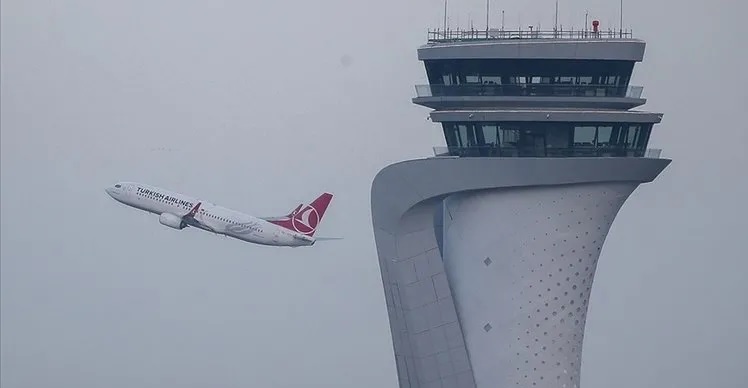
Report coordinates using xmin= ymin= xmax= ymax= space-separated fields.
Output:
xmin=371 ymin=158 xmax=670 ymax=388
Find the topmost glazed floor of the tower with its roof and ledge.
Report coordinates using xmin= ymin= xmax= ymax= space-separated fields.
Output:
xmin=413 ymin=30 xmax=646 ymax=110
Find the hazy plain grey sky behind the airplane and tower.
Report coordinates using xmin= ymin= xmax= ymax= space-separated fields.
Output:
xmin=0 ymin=0 xmax=748 ymax=388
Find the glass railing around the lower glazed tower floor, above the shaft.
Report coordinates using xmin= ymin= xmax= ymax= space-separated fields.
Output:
xmin=434 ymin=145 xmax=662 ymax=159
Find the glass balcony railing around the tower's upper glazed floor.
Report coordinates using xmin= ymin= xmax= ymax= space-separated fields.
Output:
xmin=416 ymin=84 xmax=644 ymax=98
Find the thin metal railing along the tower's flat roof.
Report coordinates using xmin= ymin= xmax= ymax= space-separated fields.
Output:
xmin=427 ymin=29 xmax=633 ymax=43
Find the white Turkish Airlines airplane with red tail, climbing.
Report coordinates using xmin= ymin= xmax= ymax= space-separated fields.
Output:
xmin=105 ymin=182 xmax=341 ymax=248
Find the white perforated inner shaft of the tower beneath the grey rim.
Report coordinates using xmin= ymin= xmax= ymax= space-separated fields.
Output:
xmin=443 ymin=182 xmax=638 ymax=388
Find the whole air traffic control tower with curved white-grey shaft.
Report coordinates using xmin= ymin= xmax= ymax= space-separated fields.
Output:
xmin=371 ymin=22 xmax=670 ymax=388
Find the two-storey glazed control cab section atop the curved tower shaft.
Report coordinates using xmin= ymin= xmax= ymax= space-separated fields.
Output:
xmin=413 ymin=23 xmax=662 ymax=157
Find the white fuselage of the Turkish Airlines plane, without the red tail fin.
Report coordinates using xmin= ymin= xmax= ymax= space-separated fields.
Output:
xmin=106 ymin=182 xmax=315 ymax=247
